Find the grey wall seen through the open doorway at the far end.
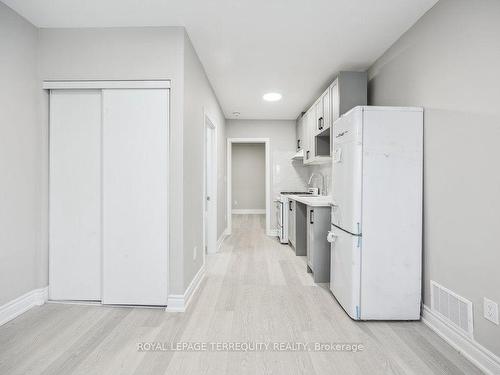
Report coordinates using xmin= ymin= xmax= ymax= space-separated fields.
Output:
xmin=231 ymin=143 xmax=266 ymax=212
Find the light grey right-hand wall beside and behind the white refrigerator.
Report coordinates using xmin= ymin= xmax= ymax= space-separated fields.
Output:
xmin=369 ymin=0 xmax=500 ymax=355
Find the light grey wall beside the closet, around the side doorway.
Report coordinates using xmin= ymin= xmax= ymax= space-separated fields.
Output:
xmin=181 ymin=33 xmax=226 ymax=290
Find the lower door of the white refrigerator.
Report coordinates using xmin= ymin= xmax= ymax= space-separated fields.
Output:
xmin=329 ymin=226 xmax=361 ymax=319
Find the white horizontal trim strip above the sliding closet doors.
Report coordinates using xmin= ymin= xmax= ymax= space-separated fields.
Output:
xmin=43 ymin=80 xmax=170 ymax=90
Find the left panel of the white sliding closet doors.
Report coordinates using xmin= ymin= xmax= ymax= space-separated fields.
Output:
xmin=49 ymin=90 xmax=101 ymax=300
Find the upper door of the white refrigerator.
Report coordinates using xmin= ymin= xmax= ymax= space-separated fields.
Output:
xmin=332 ymin=108 xmax=363 ymax=234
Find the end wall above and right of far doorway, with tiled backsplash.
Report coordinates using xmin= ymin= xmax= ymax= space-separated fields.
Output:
xmin=226 ymin=120 xmax=310 ymax=229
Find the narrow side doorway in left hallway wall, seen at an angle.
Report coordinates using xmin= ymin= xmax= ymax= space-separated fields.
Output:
xmin=203 ymin=113 xmax=217 ymax=257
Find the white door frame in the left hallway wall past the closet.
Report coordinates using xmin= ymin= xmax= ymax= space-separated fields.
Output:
xmin=203 ymin=111 xmax=218 ymax=258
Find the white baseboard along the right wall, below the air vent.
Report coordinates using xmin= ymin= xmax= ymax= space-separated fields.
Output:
xmin=422 ymin=305 xmax=500 ymax=375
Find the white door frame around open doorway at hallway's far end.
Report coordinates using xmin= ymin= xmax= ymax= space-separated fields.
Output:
xmin=226 ymin=138 xmax=273 ymax=236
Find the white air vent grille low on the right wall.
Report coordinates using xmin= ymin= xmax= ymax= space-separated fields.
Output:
xmin=431 ymin=280 xmax=473 ymax=339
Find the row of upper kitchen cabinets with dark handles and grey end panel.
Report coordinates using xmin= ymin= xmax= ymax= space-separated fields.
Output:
xmin=297 ymin=72 xmax=368 ymax=164
